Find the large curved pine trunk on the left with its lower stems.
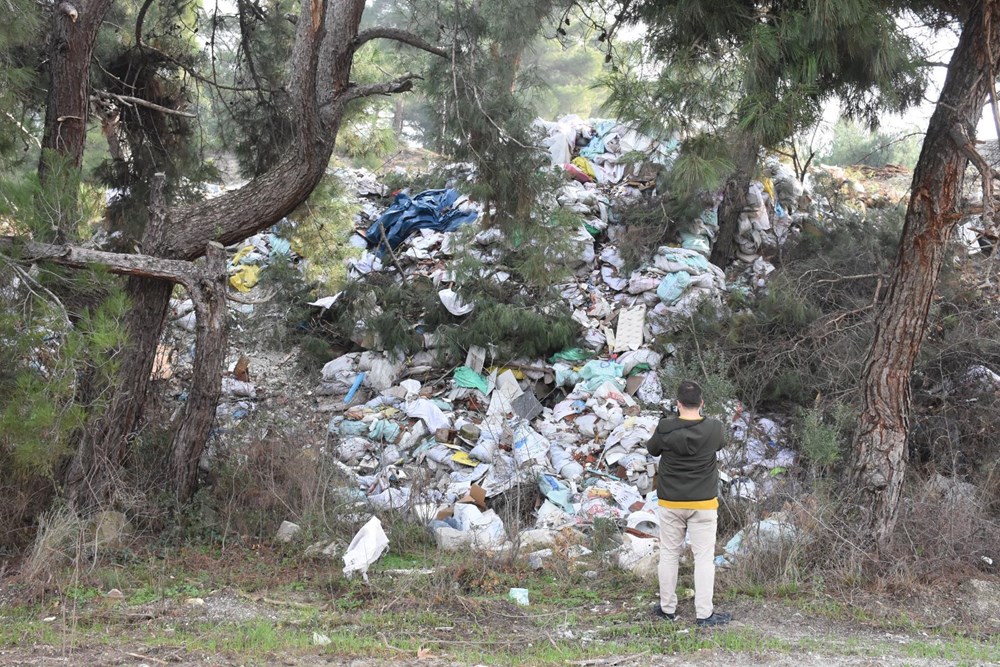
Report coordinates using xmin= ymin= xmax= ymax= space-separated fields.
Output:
xmin=65 ymin=0 xmax=372 ymax=507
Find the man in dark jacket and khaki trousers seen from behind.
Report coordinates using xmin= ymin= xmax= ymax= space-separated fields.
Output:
xmin=646 ymin=380 xmax=732 ymax=626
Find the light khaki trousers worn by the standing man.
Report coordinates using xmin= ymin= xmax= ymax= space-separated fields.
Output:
xmin=657 ymin=507 xmax=718 ymax=618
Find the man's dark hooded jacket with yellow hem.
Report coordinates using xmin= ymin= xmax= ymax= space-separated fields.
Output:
xmin=646 ymin=417 xmax=726 ymax=509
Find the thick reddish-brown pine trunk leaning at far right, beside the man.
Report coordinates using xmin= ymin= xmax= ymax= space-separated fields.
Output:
xmin=851 ymin=2 xmax=1000 ymax=550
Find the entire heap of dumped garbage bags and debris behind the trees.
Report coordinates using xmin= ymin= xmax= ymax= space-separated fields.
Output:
xmin=166 ymin=118 xmax=820 ymax=573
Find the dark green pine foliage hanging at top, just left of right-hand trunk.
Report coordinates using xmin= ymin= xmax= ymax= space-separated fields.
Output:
xmin=605 ymin=0 xmax=926 ymax=210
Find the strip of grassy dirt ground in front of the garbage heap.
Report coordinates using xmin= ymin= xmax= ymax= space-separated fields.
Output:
xmin=0 ymin=545 xmax=1000 ymax=667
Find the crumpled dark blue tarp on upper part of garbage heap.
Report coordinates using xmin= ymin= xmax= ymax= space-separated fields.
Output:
xmin=367 ymin=188 xmax=479 ymax=256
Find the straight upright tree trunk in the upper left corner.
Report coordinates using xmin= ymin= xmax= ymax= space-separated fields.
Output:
xmin=38 ymin=0 xmax=113 ymax=243
